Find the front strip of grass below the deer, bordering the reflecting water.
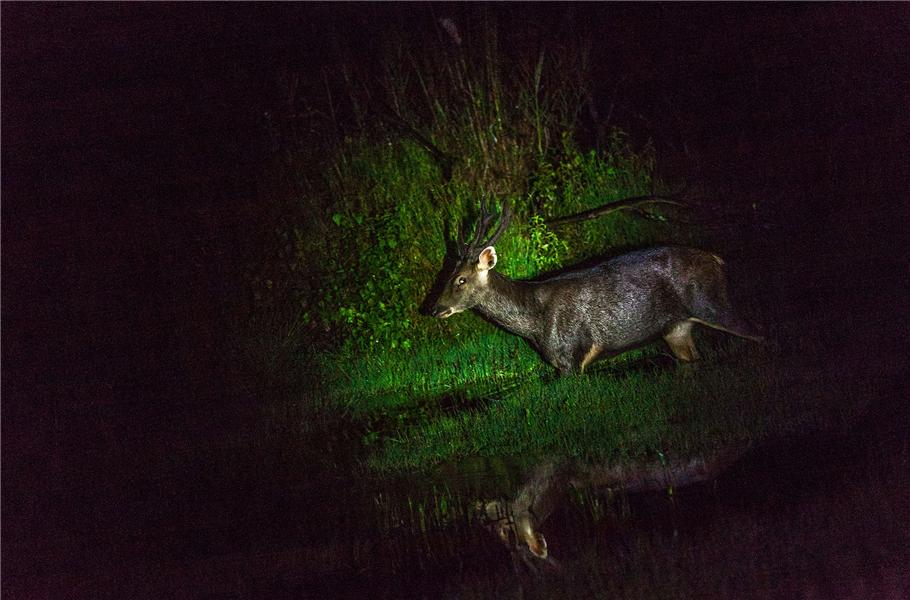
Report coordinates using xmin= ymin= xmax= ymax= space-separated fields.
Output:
xmin=369 ymin=346 xmax=769 ymax=470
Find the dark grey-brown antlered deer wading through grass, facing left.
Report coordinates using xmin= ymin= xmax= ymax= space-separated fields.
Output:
xmin=429 ymin=201 xmax=763 ymax=376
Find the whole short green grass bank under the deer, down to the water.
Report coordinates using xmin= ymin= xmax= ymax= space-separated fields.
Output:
xmin=318 ymin=324 xmax=868 ymax=474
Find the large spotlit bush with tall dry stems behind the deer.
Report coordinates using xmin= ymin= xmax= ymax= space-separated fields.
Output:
xmin=254 ymin=12 xmax=680 ymax=360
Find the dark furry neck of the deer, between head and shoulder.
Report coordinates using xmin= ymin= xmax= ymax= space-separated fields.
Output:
xmin=474 ymin=271 xmax=542 ymax=339
